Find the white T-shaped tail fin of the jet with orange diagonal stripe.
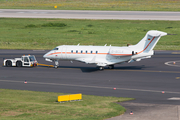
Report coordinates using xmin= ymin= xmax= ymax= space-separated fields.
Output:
xmin=131 ymin=30 xmax=167 ymax=54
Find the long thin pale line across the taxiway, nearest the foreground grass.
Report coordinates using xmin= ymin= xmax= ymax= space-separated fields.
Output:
xmin=0 ymin=80 xmax=180 ymax=94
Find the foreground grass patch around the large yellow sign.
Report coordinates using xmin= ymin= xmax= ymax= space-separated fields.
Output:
xmin=0 ymin=89 xmax=133 ymax=120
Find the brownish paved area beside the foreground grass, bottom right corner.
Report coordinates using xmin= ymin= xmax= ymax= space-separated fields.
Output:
xmin=106 ymin=102 xmax=180 ymax=120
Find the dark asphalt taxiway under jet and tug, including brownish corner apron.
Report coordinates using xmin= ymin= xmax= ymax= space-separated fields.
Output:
xmin=0 ymin=50 xmax=180 ymax=120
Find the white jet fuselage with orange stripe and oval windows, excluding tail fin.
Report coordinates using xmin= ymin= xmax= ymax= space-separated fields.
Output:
xmin=44 ymin=45 xmax=153 ymax=66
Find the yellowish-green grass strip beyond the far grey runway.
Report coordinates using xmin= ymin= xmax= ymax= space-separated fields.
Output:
xmin=0 ymin=0 xmax=180 ymax=11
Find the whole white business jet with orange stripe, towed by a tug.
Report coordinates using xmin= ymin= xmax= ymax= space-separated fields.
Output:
xmin=43 ymin=30 xmax=167 ymax=70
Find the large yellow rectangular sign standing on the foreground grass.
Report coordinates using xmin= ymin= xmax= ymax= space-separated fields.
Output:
xmin=58 ymin=94 xmax=82 ymax=102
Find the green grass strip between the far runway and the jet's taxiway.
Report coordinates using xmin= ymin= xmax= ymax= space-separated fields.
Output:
xmin=0 ymin=18 xmax=180 ymax=50
